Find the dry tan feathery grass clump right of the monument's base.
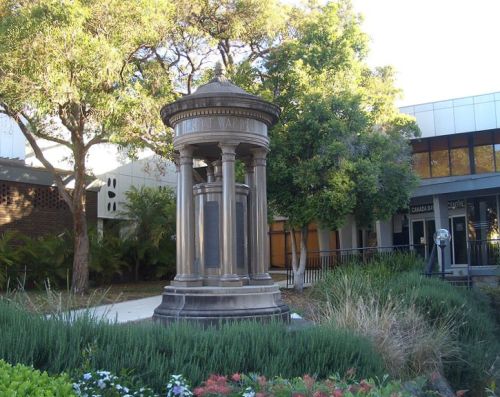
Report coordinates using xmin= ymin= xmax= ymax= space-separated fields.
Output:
xmin=317 ymin=275 xmax=456 ymax=378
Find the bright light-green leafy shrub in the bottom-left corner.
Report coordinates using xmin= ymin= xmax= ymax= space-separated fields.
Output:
xmin=0 ymin=360 xmax=75 ymax=397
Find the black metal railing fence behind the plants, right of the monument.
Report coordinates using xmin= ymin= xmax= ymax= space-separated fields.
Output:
xmin=286 ymin=244 xmax=425 ymax=287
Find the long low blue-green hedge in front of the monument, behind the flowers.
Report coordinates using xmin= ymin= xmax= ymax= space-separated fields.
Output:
xmin=0 ymin=302 xmax=383 ymax=391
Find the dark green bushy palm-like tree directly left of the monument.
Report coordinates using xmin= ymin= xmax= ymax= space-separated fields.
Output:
xmin=122 ymin=186 xmax=176 ymax=281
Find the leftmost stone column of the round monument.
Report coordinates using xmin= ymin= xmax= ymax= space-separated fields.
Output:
xmin=173 ymin=145 xmax=201 ymax=287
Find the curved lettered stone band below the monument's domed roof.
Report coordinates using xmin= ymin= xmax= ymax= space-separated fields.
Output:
xmin=175 ymin=116 xmax=267 ymax=136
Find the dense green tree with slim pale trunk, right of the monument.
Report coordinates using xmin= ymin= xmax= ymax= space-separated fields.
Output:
xmin=262 ymin=0 xmax=418 ymax=290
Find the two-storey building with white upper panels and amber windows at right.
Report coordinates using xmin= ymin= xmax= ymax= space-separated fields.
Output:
xmin=339 ymin=93 xmax=500 ymax=276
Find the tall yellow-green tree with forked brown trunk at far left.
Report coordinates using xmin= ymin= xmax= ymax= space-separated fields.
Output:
xmin=0 ymin=0 xmax=174 ymax=293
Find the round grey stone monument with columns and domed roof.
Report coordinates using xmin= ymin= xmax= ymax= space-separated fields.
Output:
xmin=153 ymin=65 xmax=290 ymax=324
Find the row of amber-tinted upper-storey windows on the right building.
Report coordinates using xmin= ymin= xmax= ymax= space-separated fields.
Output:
xmin=412 ymin=130 xmax=500 ymax=179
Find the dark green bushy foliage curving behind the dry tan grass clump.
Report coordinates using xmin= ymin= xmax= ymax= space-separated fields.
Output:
xmin=313 ymin=257 xmax=500 ymax=396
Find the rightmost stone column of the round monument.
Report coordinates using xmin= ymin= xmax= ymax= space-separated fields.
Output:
xmin=250 ymin=148 xmax=273 ymax=284
